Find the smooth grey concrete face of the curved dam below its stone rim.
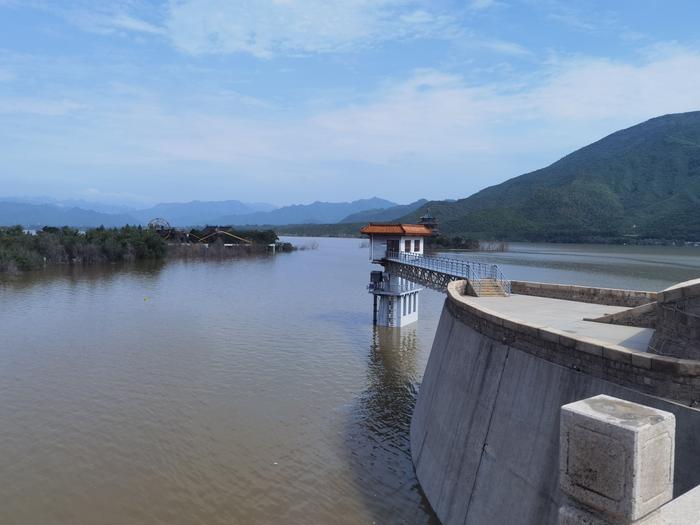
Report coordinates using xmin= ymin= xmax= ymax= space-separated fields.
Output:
xmin=411 ymin=295 xmax=700 ymax=525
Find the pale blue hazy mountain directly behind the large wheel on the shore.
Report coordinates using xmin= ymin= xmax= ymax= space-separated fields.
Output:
xmin=132 ymin=200 xmax=275 ymax=226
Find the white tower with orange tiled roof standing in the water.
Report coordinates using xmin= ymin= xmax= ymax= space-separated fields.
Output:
xmin=360 ymin=223 xmax=432 ymax=327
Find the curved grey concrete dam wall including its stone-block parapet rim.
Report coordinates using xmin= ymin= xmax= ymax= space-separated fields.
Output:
xmin=411 ymin=282 xmax=700 ymax=525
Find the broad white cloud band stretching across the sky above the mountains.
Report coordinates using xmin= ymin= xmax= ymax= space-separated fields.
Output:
xmin=0 ymin=45 xmax=700 ymax=199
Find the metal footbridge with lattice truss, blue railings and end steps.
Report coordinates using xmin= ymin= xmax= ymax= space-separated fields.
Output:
xmin=382 ymin=251 xmax=510 ymax=296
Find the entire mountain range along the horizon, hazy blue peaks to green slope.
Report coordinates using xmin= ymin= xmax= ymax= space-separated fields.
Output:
xmin=5 ymin=111 xmax=700 ymax=242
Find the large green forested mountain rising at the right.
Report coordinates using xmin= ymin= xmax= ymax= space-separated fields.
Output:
xmin=401 ymin=111 xmax=700 ymax=241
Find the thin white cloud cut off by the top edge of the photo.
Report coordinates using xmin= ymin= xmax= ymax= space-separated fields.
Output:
xmin=166 ymin=0 xmax=457 ymax=58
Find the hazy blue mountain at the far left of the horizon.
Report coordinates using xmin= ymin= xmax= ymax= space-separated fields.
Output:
xmin=0 ymin=202 xmax=139 ymax=228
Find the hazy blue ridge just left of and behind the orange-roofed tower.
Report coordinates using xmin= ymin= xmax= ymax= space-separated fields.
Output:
xmin=216 ymin=197 xmax=397 ymax=226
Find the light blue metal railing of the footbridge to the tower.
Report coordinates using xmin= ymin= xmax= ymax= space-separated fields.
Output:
xmin=386 ymin=251 xmax=511 ymax=295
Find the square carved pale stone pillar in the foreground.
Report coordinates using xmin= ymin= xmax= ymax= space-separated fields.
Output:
xmin=559 ymin=395 xmax=676 ymax=525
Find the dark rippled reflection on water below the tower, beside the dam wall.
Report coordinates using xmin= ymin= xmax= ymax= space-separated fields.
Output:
xmin=343 ymin=327 xmax=440 ymax=525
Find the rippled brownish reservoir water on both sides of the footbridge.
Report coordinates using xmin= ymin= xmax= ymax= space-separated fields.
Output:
xmin=0 ymin=239 xmax=700 ymax=524
